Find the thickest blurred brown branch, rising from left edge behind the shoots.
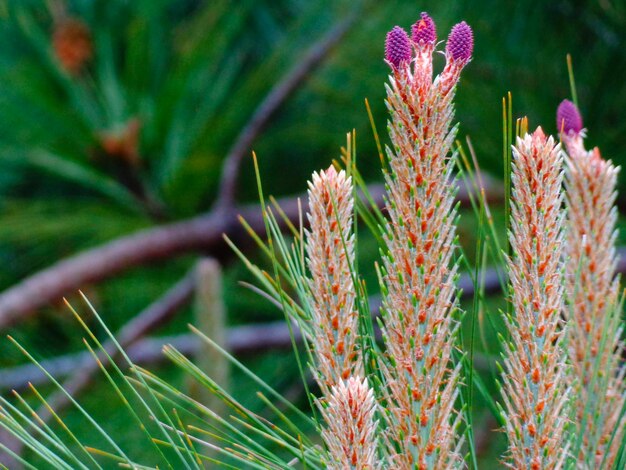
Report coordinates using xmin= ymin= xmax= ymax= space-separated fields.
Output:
xmin=0 ymin=180 xmax=502 ymax=329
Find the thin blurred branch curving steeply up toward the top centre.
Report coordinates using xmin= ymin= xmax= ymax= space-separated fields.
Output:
xmin=216 ymin=7 xmax=357 ymax=207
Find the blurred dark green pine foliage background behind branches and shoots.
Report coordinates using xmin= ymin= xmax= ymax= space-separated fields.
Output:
xmin=0 ymin=0 xmax=626 ymax=464
